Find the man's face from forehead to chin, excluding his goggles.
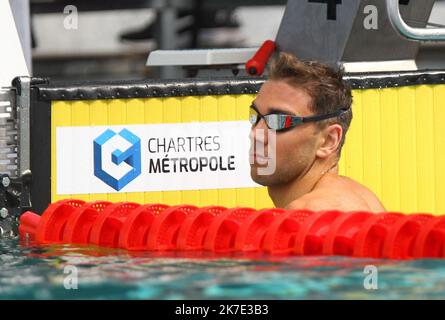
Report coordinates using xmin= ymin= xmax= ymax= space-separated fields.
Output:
xmin=250 ymin=80 xmax=320 ymax=186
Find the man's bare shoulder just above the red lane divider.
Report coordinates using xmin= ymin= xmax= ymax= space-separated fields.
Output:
xmin=286 ymin=176 xmax=386 ymax=212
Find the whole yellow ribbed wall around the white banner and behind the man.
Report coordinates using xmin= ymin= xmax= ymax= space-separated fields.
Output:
xmin=51 ymin=85 xmax=445 ymax=214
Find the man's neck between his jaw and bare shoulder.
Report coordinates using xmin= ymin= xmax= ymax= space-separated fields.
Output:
xmin=268 ymin=161 xmax=338 ymax=208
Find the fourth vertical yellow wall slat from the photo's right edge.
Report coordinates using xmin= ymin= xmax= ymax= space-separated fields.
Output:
xmin=380 ymin=88 xmax=400 ymax=211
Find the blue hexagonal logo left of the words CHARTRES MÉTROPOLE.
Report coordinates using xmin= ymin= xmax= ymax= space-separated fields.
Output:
xmin=93 ymin=129 xmax=141 ymax=191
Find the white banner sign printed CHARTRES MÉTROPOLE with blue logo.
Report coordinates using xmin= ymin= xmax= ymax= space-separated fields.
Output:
xmin=56 ymin=121 xmax=259 ymax=194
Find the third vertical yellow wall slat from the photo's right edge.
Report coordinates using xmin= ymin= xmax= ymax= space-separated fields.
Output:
xmin=394 ymin=87 xmax=419 ymax=213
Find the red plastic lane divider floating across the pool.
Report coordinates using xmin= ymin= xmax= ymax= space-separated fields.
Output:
xmin=19 ymin=200 xmax=445 ymax=259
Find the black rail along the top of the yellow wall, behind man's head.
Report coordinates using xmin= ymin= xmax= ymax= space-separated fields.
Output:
xmin=34 ymin=70 xmax=445 ymax=101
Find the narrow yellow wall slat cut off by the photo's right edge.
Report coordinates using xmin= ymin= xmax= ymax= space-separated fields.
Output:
xmin=433 ymin=85 xmax=445 ymax=214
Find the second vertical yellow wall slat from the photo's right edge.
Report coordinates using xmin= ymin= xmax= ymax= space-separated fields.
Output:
xmin=415 ymin=85 xmax=436 ymax=212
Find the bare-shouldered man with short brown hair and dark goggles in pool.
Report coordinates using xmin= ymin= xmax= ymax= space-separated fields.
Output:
xmin=249 ymin=53 xmax=386 ymax=212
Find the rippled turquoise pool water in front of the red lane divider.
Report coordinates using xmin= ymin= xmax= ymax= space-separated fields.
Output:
xmin=0 ymin=239 xmax=445 ymax=299
